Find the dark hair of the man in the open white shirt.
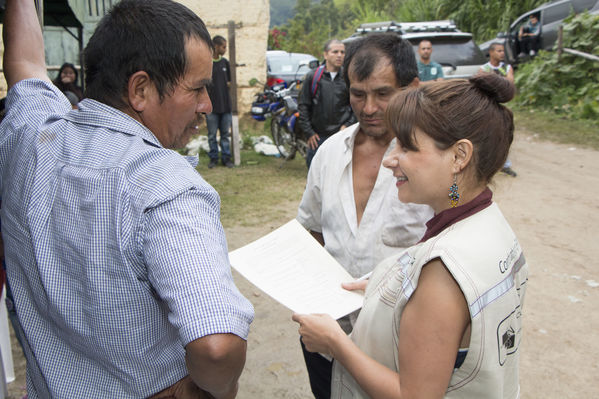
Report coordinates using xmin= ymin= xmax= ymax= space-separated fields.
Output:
xmin=343 ymin=33 xmax=418 ymax=87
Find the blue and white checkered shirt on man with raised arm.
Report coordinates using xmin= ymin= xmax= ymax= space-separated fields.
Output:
xmin=0 ymin=80 xmax=253 ymax=398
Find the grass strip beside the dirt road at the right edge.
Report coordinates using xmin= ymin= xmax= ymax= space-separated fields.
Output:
xmin=511 ymin=107 xmax=599 ymax=150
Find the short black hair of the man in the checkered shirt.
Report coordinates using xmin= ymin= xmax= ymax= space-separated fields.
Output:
xmin=84 ymin=0 xmax=213 ymax=109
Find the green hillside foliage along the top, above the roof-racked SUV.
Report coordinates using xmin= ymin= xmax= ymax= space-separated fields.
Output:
xmin=269 ymin=0 xmax=546 ymax=57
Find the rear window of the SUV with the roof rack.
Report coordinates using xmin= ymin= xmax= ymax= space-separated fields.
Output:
xmin=408 ymin=37 xmax=487 ymax=66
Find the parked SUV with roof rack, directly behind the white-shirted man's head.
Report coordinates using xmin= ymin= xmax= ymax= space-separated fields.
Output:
xmin=343 ymin=20 xmax=487 ymax=79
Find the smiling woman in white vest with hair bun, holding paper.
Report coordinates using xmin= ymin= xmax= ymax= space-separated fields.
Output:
xmin=293 ymin=74 xmax=528 ymax=398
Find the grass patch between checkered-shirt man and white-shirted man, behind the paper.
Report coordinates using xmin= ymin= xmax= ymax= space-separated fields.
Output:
xmin=197 ymin=123 xmax=308 ymax=228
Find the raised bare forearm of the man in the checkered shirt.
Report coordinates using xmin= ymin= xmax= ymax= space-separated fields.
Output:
xmin=3 ymin=0 xmax=49 ymax=88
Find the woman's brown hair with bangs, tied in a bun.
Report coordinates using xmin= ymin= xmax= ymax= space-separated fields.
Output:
xmin=386 ymin=73 xmax=515 ymax=183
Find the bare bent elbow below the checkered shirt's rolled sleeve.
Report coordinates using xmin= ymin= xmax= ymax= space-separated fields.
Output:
xmin=185 ymin=334 xmax=247 ymax=399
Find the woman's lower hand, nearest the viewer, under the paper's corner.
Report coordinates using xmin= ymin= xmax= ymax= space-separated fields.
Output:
xmin=291 ymin=313 xmax=347 ymax=357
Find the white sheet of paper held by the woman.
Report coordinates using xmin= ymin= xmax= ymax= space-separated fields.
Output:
xmin=229 ymin=219 xmax=364 ymax=319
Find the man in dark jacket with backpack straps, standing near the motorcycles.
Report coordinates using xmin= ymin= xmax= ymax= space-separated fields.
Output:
xmin=298 ymin=39 xmax=356 ymax=168
